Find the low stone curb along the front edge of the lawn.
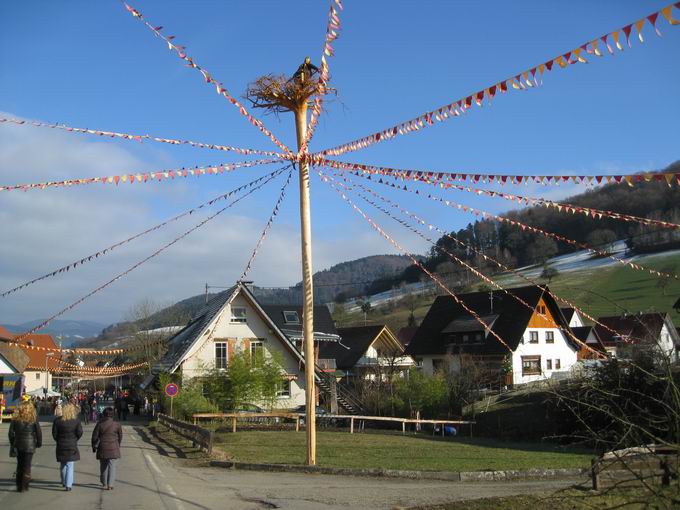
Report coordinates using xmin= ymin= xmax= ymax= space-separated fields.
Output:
xmin=210 ymin=460 xmax=590 ymax=482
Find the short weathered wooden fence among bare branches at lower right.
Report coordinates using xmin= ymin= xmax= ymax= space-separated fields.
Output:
xmin=590 ymin=445 xmax=680 ymax=490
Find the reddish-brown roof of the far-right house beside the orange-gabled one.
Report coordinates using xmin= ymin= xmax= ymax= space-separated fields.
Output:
xmin=595 ymin=313 xmax=672 ymax=347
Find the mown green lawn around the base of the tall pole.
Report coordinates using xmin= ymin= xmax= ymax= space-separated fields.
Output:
xmin=215 ymin=431 xmax=593 ymax=471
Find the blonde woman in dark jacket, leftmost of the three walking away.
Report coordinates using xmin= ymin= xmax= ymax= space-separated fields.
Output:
xmin=9 ymin=402 xmax=42 ymax=492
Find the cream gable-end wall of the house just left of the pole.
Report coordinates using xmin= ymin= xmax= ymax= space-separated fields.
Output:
xmin=177 ymin=295 xmax=305 ymax=409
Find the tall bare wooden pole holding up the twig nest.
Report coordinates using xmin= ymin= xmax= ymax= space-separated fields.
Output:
xmin=294 ymin=100 xmax=316 ymax=466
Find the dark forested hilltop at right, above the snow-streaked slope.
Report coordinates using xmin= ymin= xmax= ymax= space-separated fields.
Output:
xmin=401 ymin=161 xmax=680 ymax=281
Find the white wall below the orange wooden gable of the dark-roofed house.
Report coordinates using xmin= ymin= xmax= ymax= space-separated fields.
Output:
xmin=512 ymin=328 xmax=578 ymax=384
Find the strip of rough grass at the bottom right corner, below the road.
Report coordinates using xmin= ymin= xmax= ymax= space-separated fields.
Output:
xmin=410 ymin=488 xmax=678 ymax=510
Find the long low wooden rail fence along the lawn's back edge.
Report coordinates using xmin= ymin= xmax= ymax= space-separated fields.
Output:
xmin=192 ymin=413 xmax=476 ymax=437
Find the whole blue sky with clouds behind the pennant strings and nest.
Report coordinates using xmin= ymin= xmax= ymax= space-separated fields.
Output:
xmin=0 ymin=0 xmax=680 ymax=323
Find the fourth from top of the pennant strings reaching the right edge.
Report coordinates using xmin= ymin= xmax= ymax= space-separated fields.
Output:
xmin=346 ymin=167 xmax=680 ymax=280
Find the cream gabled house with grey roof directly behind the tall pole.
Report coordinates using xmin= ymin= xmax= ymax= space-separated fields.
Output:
xmin=143 ymin=283 xmax=346 ymax=409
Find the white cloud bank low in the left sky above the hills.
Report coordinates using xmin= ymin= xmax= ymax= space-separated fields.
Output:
xmin=0 ymin=113 xmax=420 ymax=324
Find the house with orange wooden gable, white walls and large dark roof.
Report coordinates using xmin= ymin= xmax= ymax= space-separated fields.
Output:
xmin=406 ymin=286 xmax=579 ymax=384
